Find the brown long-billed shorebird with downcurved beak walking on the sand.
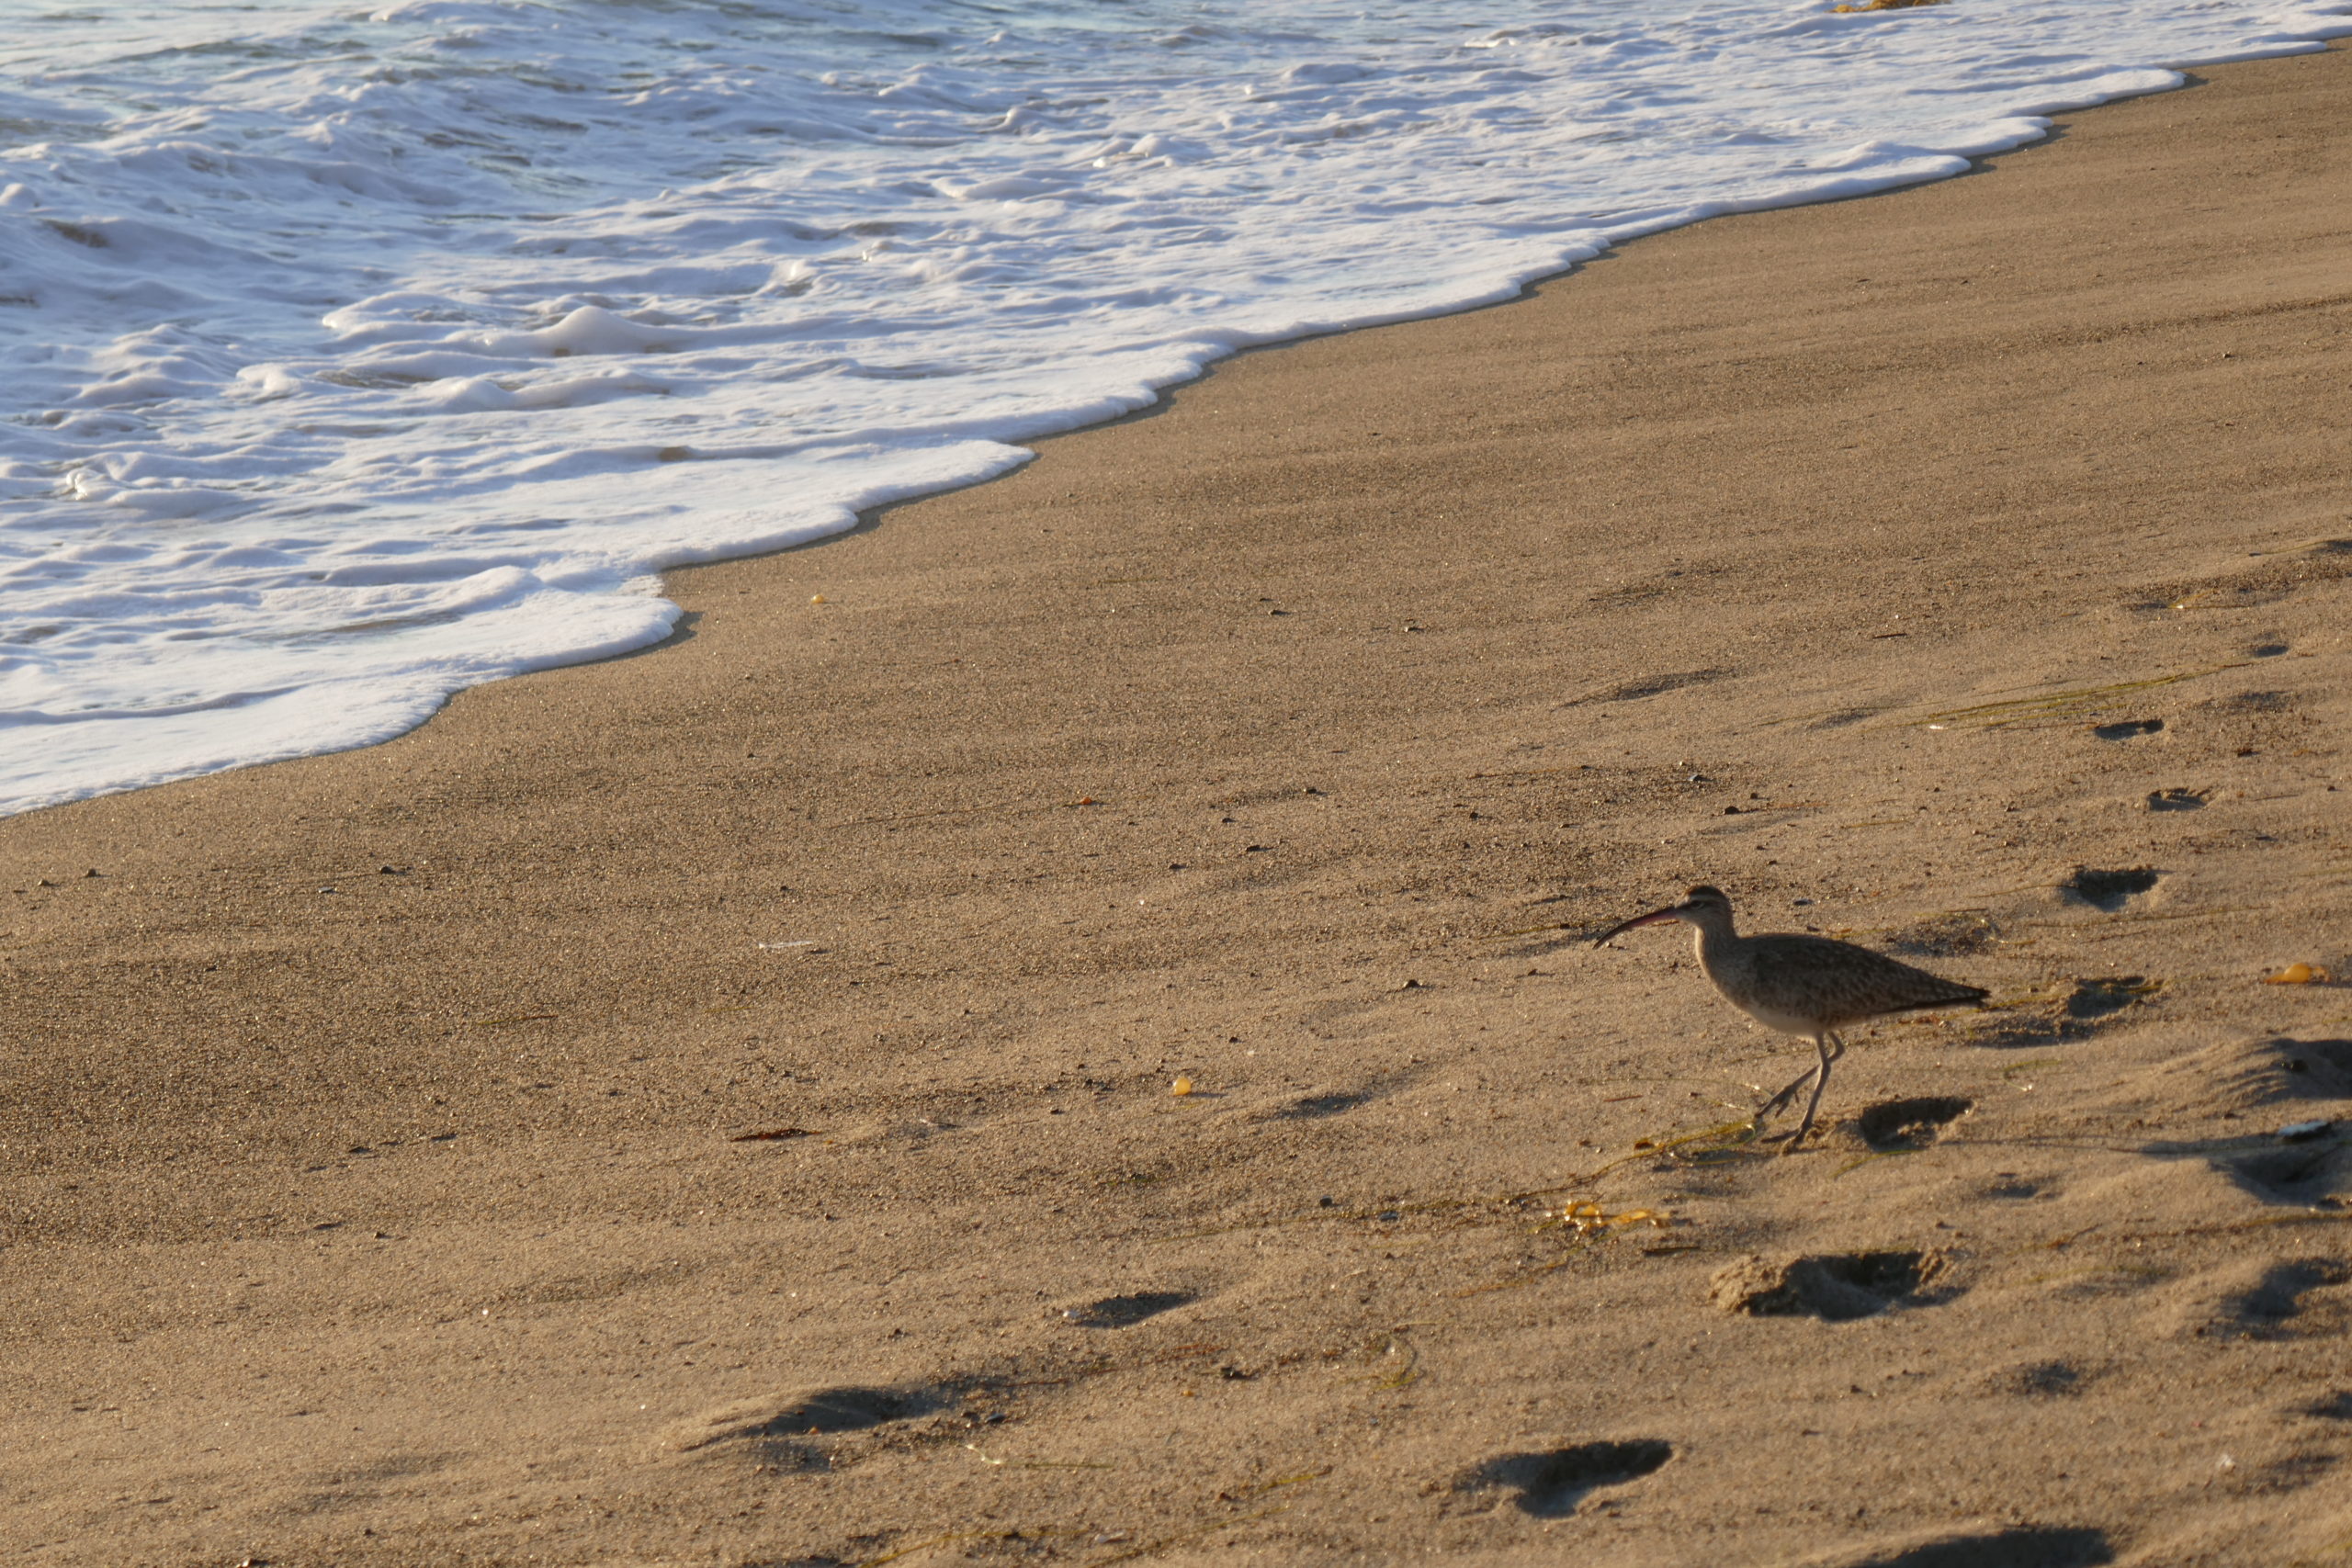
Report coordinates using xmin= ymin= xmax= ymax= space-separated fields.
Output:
xmin=1592 ymin=886 xmax=1985 ymax=1155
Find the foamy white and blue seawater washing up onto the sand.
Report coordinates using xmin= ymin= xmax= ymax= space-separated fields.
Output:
xmin=0 ymin=0 xmax=2352 ymax=813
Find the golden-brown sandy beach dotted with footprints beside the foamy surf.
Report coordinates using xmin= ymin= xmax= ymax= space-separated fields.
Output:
xmin=0 ymin=36 xmax=2352 ymax=1568
